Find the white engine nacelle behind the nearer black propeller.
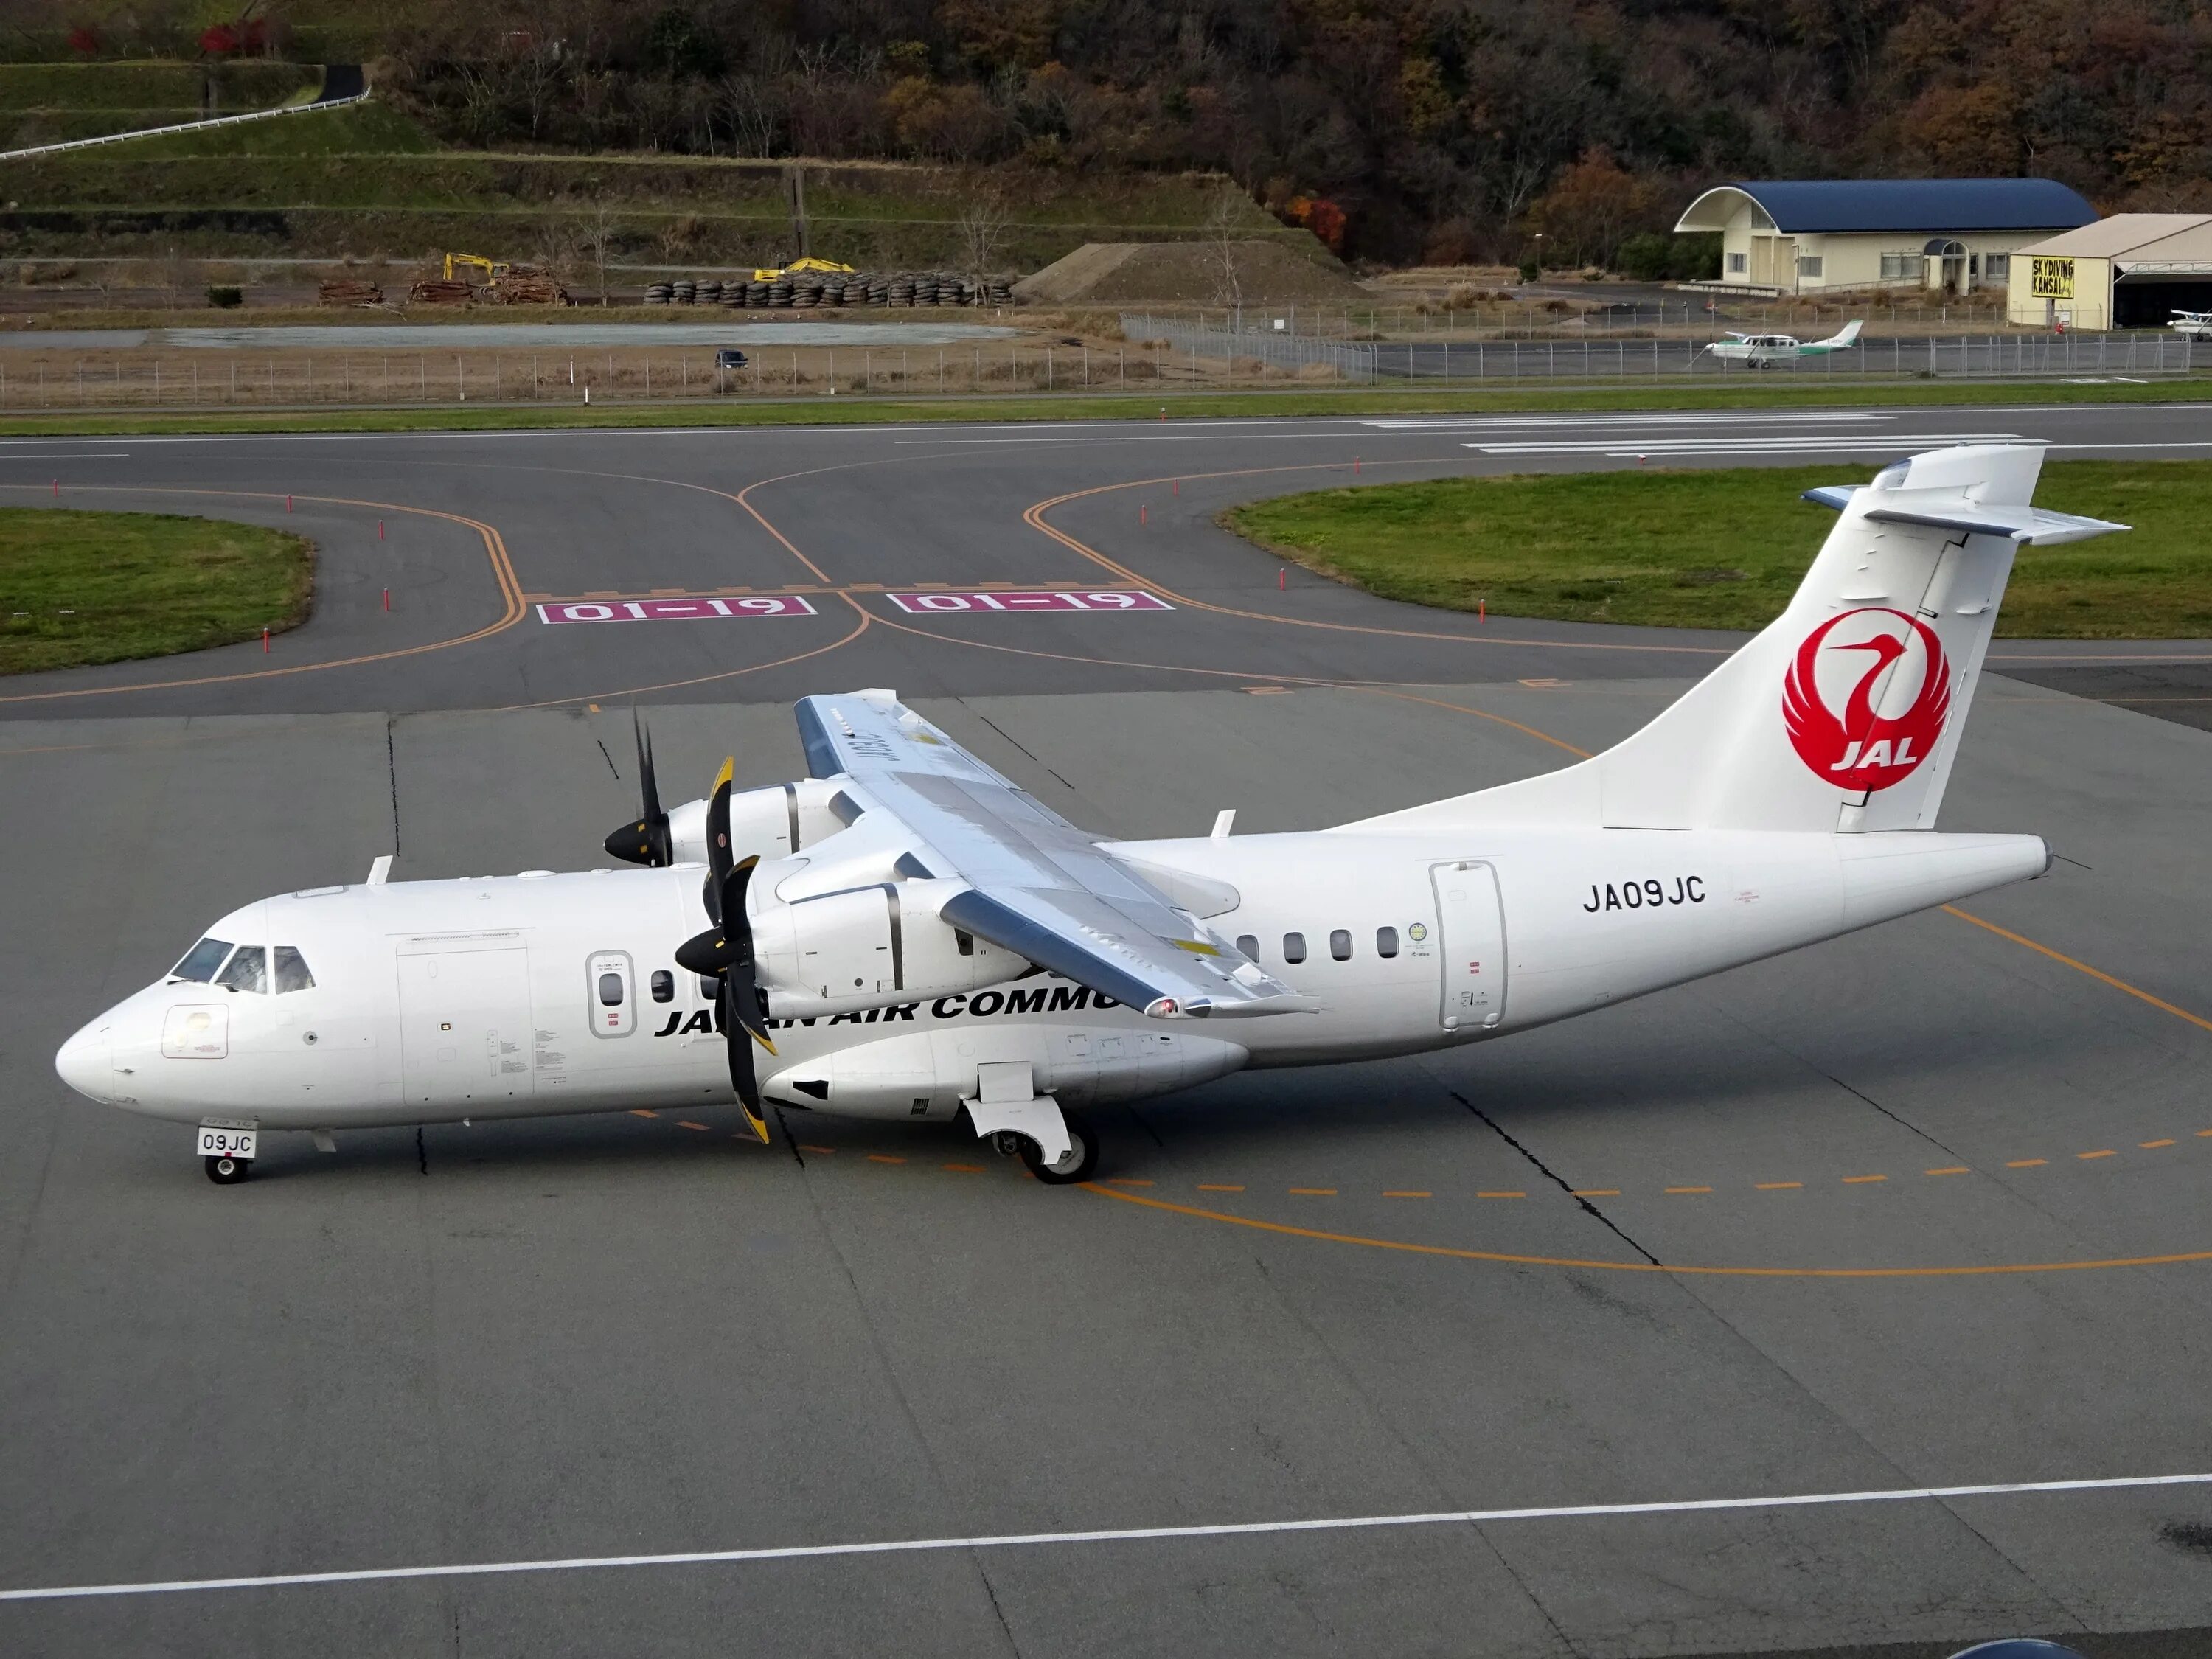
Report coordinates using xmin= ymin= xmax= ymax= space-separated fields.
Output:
xmin=752 ymin=880 xmax=1029 ymax=1020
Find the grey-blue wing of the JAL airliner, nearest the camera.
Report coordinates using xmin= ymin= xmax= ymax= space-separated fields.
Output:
xmin=799 ymin=690 xmax=1316 ymax=1018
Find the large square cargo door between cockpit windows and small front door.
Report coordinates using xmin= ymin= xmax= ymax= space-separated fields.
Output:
xmin=398 ymin=938 xmax=533 ymax=1108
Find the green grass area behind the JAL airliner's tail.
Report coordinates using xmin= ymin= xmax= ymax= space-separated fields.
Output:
xmin=1223 ymin=460 xmax=2212 ymax=639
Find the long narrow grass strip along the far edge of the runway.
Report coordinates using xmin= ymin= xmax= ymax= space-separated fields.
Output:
xmin=0 ymin=376 xmax=2212 ymax=438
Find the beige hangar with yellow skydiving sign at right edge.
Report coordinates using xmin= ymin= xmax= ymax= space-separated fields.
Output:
xmin=2004 ymin=212 xmax=2212 ymax=327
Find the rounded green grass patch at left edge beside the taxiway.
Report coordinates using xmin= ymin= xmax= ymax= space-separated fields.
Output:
xmin=0 ymin=507 xmax=314 ymax=675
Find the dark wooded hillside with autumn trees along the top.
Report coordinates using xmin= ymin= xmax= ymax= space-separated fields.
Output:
xmin=17 ymin=0 xmax=2212 ymax=274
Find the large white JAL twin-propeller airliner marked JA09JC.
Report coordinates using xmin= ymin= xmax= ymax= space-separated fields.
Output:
xmin=55 ymin=445 xmax=2126 ymax=1183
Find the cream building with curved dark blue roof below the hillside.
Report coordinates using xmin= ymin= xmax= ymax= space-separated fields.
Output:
xmin=1674 ymin=179 xmax=2097 ymax=294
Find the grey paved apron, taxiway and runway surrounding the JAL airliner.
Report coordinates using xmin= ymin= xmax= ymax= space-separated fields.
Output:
xmin=0 ymin=407 xmax=2212 ymax=1657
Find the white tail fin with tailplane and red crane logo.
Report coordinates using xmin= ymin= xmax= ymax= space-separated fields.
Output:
xmin=1358 ymin=445 xmax=2126 ymax=832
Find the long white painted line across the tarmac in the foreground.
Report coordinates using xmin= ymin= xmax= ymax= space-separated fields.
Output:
xmin=0 ymin=1473 xmax=2212 ymax=1601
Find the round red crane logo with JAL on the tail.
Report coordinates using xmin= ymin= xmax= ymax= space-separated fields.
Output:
xmin=1783 ymin=606 xmax=1951 ymax=790
